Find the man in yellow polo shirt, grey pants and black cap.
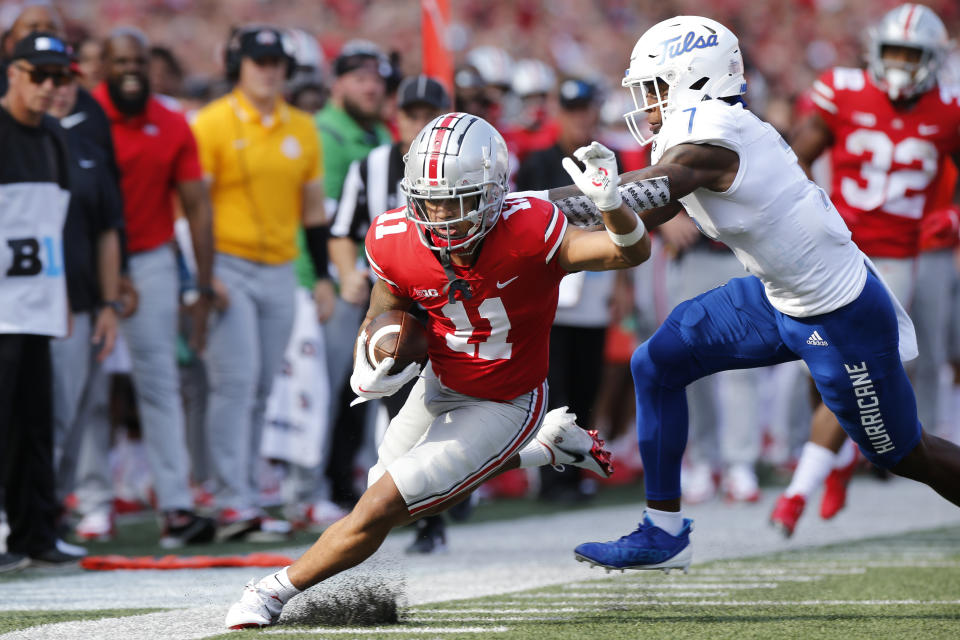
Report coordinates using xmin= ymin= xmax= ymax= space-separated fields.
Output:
xmin=193 ymin=26 xmax=333 ymax=538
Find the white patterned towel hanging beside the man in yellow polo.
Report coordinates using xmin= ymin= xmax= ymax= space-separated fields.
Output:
xmin=260 ymin=288 xmax=330 ymax=467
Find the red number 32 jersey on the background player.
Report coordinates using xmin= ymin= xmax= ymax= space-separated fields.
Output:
xmin=811 ymin=67 xmax=960 ymax=258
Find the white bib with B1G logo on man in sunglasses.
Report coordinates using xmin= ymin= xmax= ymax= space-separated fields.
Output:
xmin=0 ymin=182 xmax=69 ymax=337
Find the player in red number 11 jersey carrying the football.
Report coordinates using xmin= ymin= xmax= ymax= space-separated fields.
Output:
xmin=226 ymin=113 xmax=650 ymax=628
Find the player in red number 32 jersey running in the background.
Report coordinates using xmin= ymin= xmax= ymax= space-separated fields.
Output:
xmin=771 ymin=3 xmax=960 ymax=536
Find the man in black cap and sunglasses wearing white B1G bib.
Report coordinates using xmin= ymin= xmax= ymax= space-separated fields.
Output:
xmin=0 ymin=32 xmax=79 ymax=570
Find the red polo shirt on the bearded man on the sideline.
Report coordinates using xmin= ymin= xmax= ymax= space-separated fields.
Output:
xmin=93 ymin=82 xmax=203 ymax=253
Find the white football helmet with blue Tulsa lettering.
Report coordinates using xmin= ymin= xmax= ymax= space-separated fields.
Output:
xmin=622 ymin=16 xmax=747 ymax=144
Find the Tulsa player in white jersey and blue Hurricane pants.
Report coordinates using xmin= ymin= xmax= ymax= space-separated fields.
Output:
xmin=550 ymin=16 xmax=960 ymax=569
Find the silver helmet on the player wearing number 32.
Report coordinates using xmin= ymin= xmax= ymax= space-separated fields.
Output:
xmin=867 ymin=3 xmax=949 ymax=100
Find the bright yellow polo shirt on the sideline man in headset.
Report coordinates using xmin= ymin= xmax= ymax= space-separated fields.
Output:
xmin=192 ymin=89 xmax=323 ymax=264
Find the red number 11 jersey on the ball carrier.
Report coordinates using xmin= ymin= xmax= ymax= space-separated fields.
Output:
xmin=366 ymin=197 xmax=567 ymax=401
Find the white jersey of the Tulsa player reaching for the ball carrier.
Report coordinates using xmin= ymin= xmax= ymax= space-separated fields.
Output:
xmin=651 ymin=100 xmax=867 ymax=317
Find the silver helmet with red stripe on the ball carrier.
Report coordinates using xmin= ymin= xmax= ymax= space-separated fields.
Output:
xmin=400 ymin=113 xmax=509 ymax=253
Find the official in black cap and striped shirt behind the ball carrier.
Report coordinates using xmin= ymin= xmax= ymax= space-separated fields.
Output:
xmin=322 ymin=75 xmax=451 ymax=553
